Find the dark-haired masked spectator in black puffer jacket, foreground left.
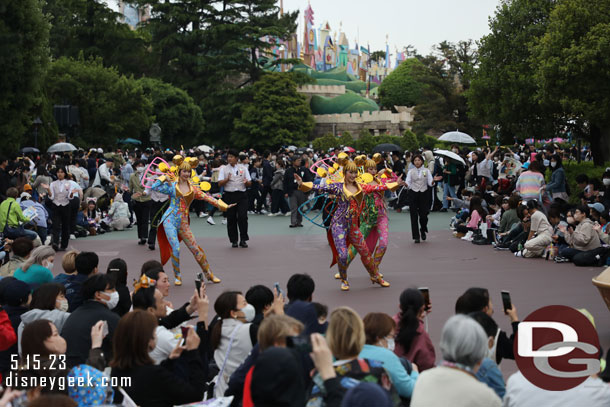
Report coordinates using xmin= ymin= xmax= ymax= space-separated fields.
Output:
xmin=61 ymin=274 xmax=119 ymax=367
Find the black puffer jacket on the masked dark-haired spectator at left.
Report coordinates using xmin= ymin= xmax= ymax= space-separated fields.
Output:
xmin=61 ymin=300 xmax=120 ymax=366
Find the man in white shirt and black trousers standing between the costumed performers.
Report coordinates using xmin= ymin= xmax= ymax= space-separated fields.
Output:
xmin=218 ymin=150 xmax=252 ymax=247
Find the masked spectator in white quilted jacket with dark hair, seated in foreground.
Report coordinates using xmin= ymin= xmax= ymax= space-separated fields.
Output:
xmin=210 ymin=291 xmax=255 ymax=397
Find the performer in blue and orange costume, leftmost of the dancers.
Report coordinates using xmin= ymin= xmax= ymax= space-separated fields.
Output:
xmin=151 ymin=156 xmax=235 ymax=285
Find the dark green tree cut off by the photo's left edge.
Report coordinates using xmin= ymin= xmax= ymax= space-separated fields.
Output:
xmin=0 ymin=0 xmax=49 ymax=154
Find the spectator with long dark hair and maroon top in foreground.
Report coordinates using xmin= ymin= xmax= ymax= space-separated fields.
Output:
xmin=394 ymin=288 xmax=436 ymax=372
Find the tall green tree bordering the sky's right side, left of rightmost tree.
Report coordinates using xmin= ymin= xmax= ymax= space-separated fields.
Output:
xmin=467 ymin=0 xmax=556 ymax=143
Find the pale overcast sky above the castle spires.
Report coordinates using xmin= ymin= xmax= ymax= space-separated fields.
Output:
xmin=284 ymin=0 xmax=500 ymax=55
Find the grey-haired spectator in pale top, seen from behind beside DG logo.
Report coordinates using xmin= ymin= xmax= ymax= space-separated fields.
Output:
xmin=411 ymin=315 xmax=502 ymax=407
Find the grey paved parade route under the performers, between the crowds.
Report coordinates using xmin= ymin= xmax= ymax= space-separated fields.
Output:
xmin=54 ymin=212 xmax=610 ymax=374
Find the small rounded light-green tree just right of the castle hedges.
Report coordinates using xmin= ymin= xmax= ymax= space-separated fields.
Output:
xmin=379 ymin=58 xmax=426 ymax=108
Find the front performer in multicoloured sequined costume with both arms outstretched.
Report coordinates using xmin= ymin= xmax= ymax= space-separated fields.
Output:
xmin=295 ymin=161 xmax=399 ymax=291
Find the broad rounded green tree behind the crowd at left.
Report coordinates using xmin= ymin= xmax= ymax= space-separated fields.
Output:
xmin=45 ymin=57 xmax=153 ymax=147
